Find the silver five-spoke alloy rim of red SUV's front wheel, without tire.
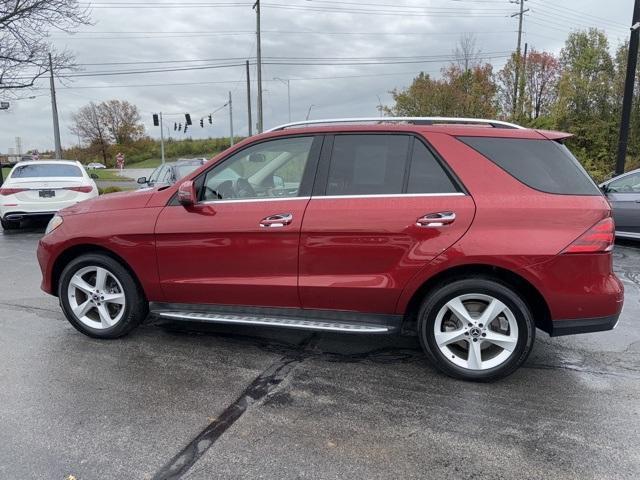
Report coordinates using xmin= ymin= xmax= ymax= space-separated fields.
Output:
xmin=67 ymin=266 xmax=126 ymax=330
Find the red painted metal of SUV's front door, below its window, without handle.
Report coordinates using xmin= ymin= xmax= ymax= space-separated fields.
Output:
xmin=156 ymin=198 xmax=308 ymax=307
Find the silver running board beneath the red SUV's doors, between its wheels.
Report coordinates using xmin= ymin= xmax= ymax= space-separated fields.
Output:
xmin=154 ymin=310 xmax=397 ymax=333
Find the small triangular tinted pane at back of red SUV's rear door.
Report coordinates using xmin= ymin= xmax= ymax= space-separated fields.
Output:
xmin=407 ymin=140 xmax=459 ymax=193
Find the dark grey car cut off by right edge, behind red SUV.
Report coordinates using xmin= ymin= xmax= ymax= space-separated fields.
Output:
xmin=607 ymin=172 xmax=640 ymax=235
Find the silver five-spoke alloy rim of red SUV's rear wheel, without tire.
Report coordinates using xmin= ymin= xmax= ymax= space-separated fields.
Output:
xmin=433 ymin=293 xmax=518 ymax=371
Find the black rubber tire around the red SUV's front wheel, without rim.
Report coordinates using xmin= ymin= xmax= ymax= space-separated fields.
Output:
xmin=58 ymin=253 xmax=149 ymax=339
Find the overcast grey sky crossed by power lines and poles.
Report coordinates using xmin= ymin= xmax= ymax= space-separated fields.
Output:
xmin=0 ymin=0 xmax=633 ymax=152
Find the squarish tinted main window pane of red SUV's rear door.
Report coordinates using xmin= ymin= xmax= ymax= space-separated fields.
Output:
xmin=327 ymin=135 xmax=411 ymax=195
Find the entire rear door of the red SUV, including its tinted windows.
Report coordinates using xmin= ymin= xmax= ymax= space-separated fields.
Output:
xmin=299 ymin=133 xmax=475 ymax=313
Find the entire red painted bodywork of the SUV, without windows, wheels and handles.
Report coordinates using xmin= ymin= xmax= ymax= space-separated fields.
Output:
xmin=38 ymin=125 xmax=623 ymax=334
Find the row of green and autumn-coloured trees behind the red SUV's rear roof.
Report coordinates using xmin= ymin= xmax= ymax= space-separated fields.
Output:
xmin=383 ymin=28 xmax=640 ymax=180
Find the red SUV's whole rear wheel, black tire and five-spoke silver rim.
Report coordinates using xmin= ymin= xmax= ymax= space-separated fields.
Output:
xmin=418 ymin=277 xmax=535 ymax=381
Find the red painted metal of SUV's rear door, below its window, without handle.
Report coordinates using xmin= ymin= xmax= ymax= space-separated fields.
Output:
xmin=300 ymin=195 xmax=475 ymax=313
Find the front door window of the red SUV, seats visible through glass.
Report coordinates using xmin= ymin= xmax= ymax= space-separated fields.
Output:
xmin=200 ymin=137 xmax=313 ymax=201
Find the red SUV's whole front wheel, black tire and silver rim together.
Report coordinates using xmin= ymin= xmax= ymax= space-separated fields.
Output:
xmin=58 ymin=254 xmax=148 ymax=338
